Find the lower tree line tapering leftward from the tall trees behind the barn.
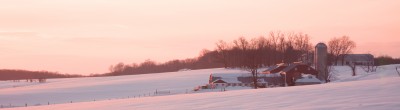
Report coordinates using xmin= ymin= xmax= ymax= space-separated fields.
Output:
xmin=96 ymin=49 xmax=223 ymax=76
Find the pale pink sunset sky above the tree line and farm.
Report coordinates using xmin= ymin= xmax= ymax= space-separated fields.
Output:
xmin=0 ymin=0 xmax=400 ymax=74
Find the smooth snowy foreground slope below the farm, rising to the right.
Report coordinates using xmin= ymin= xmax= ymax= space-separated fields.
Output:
xmin=3 ymin=77 xmax=400 ymax=110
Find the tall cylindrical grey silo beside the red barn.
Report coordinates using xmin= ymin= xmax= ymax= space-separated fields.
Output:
xmin=314 ymin=43 xmax=328 ymax=82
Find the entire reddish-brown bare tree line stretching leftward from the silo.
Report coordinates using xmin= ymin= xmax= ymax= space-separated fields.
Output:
xmin=101 ymin=31 xmax=313 ymax=81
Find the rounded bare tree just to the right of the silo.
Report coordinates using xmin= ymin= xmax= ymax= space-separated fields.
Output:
xmin=328 ymin=36 xmax=356 ymax=65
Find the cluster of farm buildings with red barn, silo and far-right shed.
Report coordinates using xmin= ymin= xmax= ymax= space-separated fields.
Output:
xmin=202 ymin=43 xmax=374 ymax=89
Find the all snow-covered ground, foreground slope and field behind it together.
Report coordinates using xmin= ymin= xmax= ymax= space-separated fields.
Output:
xmin=0 ymin=65 xmax=400 ymax=110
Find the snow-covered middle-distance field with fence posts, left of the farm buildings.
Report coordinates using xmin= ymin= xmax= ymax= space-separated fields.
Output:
xmin=0 ymin=68 xmax=250 ymax=107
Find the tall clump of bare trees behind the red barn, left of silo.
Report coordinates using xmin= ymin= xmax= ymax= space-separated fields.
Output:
xmin=215 ymin=31 xmax=313 ymax=68
